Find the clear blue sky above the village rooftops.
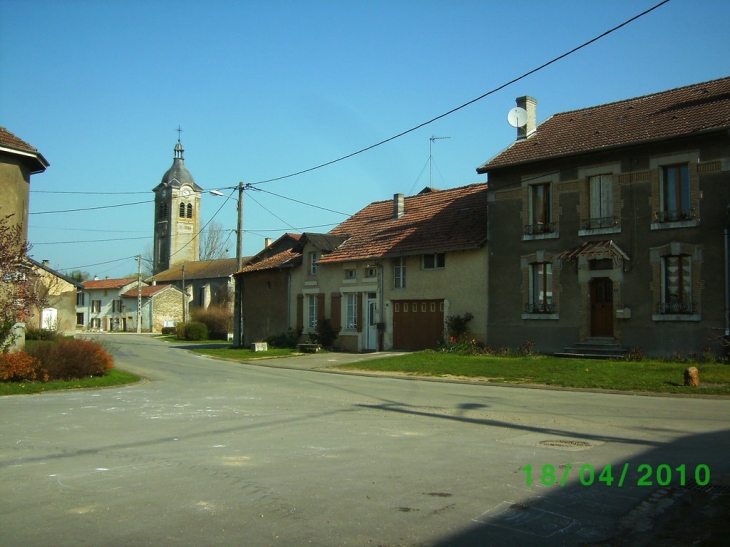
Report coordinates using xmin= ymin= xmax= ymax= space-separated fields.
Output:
xmin=0 ymin=0 xmax=730 ymax=278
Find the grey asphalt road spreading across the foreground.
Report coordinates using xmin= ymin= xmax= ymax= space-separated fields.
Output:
xmin=0 ymin=335 xmax=730 ymax=547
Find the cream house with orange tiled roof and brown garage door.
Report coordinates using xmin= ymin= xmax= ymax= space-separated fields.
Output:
xmin=289 ymin=184 xmax=488 ymax=351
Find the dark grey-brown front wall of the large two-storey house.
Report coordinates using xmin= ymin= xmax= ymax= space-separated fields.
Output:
xmin=487 ymin=132 xmax=730 ymax=355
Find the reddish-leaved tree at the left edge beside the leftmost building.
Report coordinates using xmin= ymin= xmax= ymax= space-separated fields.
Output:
xmin=0 ymin=215 xmax=48 ymax=353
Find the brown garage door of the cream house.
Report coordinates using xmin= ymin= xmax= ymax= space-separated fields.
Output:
xmin=393 ymin=300 xmax=444 ymax=350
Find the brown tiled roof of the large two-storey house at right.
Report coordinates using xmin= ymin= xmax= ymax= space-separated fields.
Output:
xmin=477 ymin=77 xmax=730 ymax=173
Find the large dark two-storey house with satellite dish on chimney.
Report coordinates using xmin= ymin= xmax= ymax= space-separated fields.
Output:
xmin=477 ymin=78 xmax=730 ymax=355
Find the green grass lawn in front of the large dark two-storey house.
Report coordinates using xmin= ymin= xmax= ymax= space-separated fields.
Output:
xmin=337 ymin=351 xmax=730 ymax=395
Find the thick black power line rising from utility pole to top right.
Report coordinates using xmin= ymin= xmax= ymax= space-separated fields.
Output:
xmin=250 ymin=0 xmax=669 ymax=186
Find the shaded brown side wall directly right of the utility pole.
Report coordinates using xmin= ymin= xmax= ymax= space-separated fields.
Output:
xmin=237 ymin=269 xmax=290 ymax=346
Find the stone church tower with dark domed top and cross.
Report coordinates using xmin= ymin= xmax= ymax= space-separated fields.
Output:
xmin=152 ymin=138 xmax=203 ymax=274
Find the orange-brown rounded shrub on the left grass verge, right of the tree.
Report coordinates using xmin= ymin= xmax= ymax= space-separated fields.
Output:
xmin=28 ymin=338 xmax=114 ymax=381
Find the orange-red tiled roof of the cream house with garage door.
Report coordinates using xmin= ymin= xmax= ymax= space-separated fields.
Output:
xmin=319 ymin=184 xmax=487 ymax=263
